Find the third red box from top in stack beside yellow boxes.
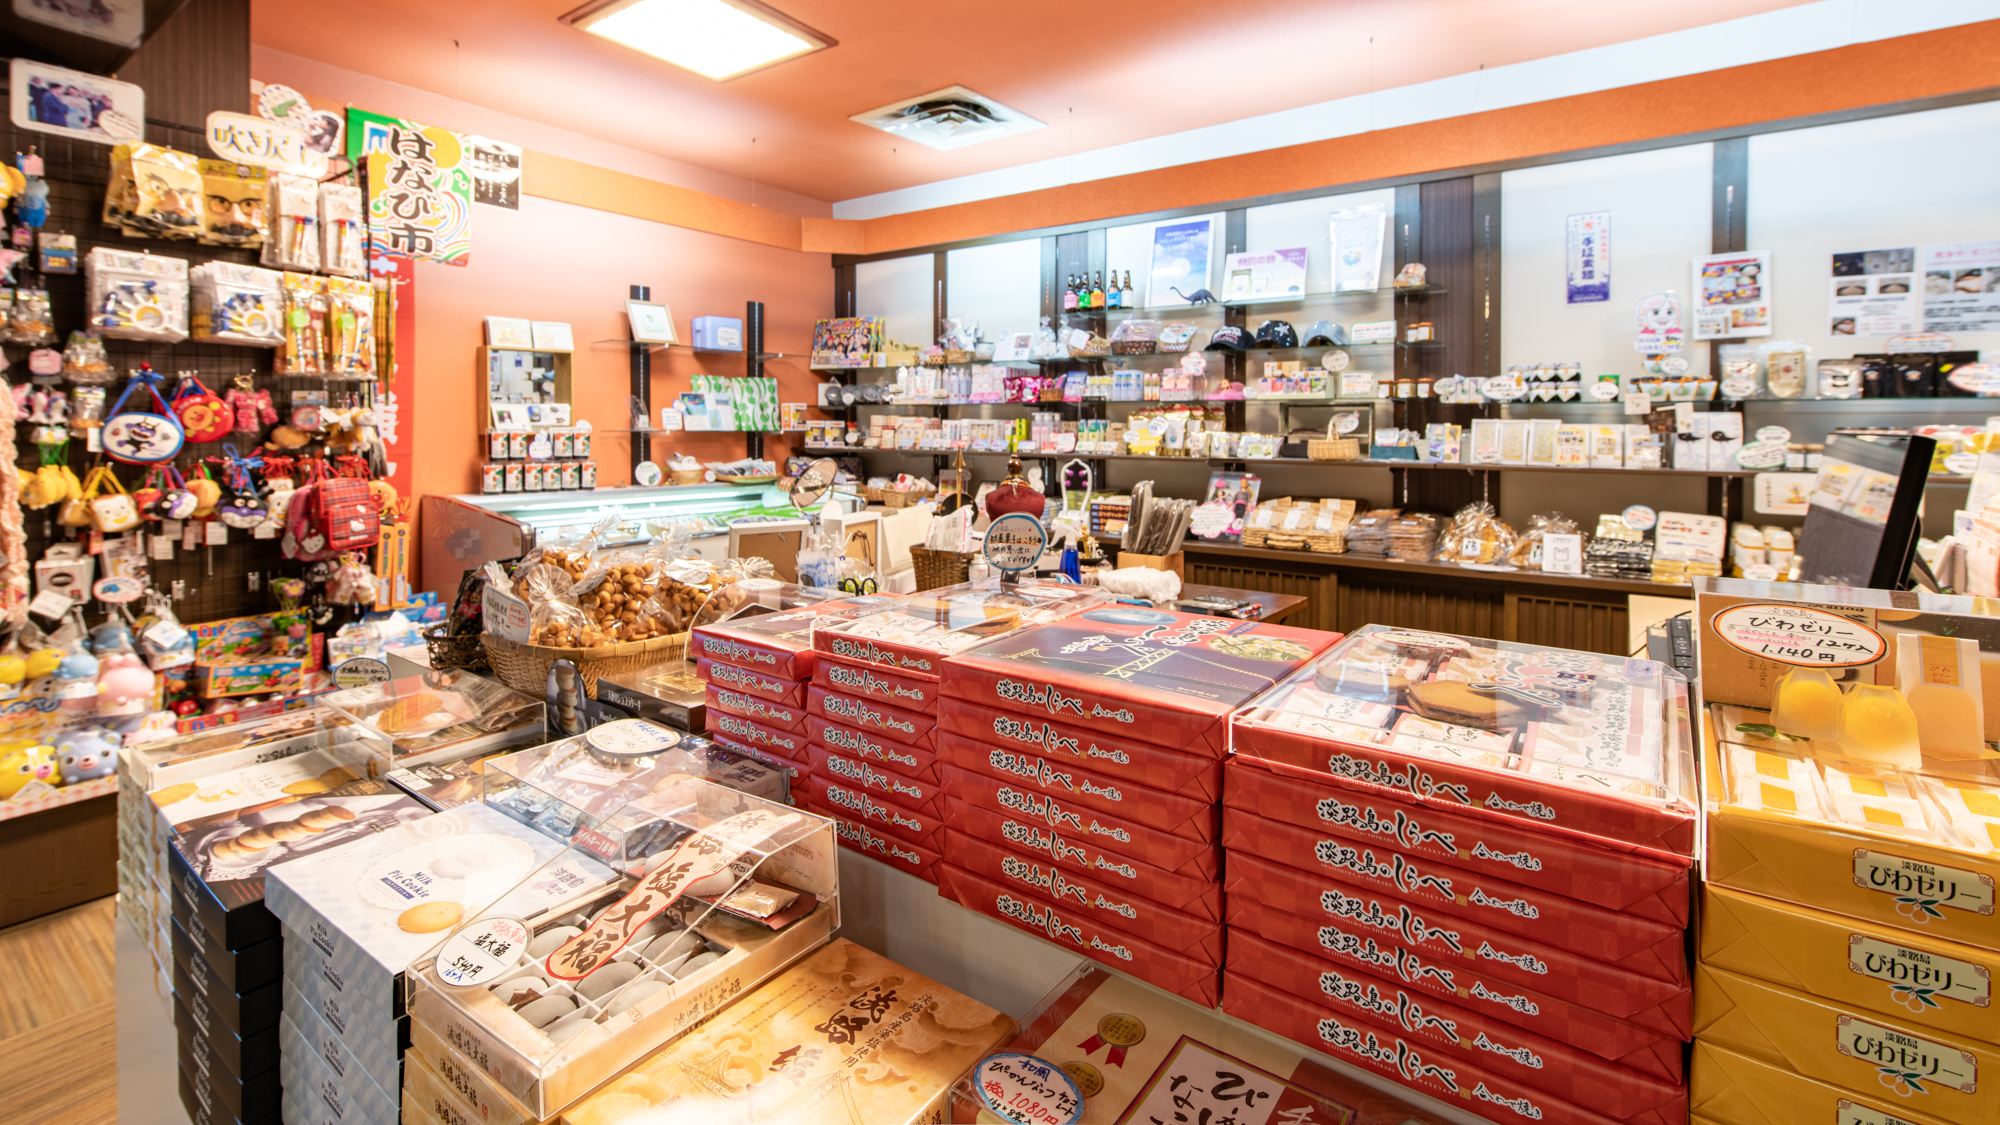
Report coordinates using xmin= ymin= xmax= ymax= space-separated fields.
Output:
xmin=1222 ymin=809 xmax=1688 ymax=985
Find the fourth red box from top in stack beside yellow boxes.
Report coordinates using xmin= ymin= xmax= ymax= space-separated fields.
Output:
xmin=1226 ymin=853 xmax=1694 ymax=1032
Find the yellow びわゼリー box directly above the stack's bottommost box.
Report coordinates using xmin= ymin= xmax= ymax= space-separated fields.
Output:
xmin=1694 ymin=952 xmax=2000 ymax=1125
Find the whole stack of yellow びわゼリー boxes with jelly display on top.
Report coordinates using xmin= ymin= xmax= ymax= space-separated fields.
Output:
xmin=1690 ymin=579 xmax=2000 ymax=1125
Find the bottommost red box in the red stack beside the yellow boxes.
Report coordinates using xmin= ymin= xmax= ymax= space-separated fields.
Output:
xmin=1222 ymin=971 xmax=1614 ymax=1125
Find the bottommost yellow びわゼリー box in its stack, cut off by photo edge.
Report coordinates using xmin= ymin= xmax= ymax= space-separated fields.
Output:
xmin=1688 ymin=1039 xmax=1948 ymax=1125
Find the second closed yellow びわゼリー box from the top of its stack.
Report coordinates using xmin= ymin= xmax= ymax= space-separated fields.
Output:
xmin=1702 ymin=887 xmax=2000 ymax=1043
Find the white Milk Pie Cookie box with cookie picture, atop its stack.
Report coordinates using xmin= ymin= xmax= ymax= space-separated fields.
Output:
xmin=264 ymin=805 xmax=580 ymax=1089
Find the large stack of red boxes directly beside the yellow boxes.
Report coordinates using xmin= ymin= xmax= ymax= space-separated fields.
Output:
xmin=1222 ymin=625 xmax=1696 ymax=1125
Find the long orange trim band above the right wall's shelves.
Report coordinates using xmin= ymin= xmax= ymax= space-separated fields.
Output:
xmin=840 ymin=20 xmax=2000 ymax=254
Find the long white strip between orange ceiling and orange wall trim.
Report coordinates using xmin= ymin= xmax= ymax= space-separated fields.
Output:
xmin=834 ymin=0 xmax=2000 ymax=218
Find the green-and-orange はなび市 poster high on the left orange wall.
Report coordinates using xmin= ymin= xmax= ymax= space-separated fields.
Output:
xmin=348 ymin=108 xmax=472 ymax=266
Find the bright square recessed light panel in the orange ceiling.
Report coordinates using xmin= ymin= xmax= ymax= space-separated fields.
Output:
xmin=562 ymin=0 xmax=834 ymax=82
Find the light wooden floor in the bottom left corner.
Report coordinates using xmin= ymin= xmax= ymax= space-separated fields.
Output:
xmin=0 ymin=899 xmax=118 ymax=1125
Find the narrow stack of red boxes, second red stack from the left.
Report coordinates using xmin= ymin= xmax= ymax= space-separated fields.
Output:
xmin=796 ymin=583 xmax=1104 ymax=883
